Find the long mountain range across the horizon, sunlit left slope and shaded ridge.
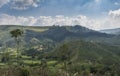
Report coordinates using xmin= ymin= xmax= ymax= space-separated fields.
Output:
xmin=0 ymin=25 xmax=114 ymax=48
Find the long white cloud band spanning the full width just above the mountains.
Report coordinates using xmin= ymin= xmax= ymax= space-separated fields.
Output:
xmin=0 ymin=9 xmax=120 ymax=30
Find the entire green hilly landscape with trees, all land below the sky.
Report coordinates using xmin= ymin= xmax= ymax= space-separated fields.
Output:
xmin=0 ymin=25 xmax=120 ymax=76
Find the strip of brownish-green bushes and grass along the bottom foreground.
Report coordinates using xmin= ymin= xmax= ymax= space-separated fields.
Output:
xmin=0 ymin=64 xmax=120 ymax=76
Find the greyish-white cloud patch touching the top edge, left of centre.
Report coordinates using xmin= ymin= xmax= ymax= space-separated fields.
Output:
xmin=12 ymin=0 xmax=41 ymax=10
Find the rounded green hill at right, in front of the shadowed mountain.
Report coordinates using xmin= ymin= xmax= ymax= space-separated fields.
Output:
xmin=52 ymin=40 xmax=120 ymax=65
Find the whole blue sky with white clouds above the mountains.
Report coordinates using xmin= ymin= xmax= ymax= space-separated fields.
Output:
xmin=0 ymin=0 xmax=120 ymax=30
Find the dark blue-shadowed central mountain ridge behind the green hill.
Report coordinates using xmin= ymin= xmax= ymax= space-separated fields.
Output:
xmin=35 ymin=25 xmax=113 ymax=41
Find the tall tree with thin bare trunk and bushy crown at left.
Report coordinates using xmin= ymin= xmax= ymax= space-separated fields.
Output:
xmin=10 ymin=29 xmax=23 ymax=62
